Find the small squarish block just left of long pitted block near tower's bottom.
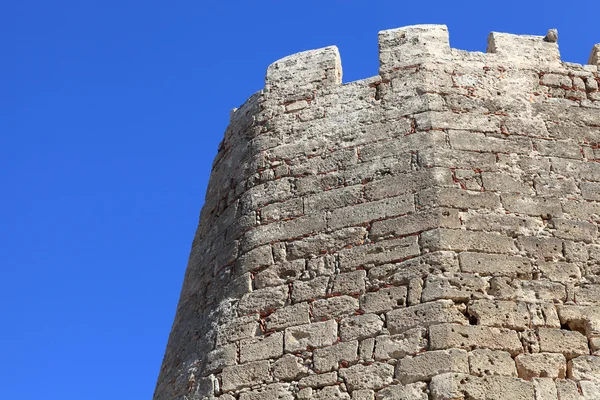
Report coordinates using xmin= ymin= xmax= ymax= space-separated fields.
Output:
xmin=375 ymin=328 xmax=427 ymax=361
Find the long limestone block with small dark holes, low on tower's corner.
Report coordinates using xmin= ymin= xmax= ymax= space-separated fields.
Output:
xmin=429 ymin=324 xmax=523 ymax=356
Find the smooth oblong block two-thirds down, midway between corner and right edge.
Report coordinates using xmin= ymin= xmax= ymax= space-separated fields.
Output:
xmin=458 ymin=252 xmax=532 ymax=278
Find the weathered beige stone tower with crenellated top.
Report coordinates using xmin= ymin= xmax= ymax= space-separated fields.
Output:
xmin=154 ymin=25 xmax=600 ymax=400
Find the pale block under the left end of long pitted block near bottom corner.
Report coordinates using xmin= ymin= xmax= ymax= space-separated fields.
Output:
xmin=396 ymin=349 xmax=469 ymax=385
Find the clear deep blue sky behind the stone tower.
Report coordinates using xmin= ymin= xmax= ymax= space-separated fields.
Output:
xmin=0 ymin=0 xmax=600 ymax=400
